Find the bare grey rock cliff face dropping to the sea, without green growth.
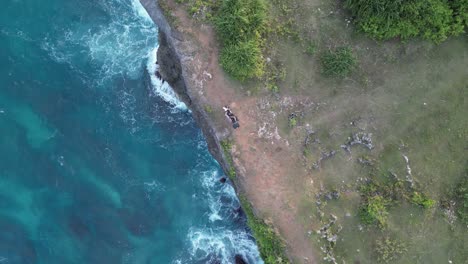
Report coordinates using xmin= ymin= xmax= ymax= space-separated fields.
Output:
xmin=140 ymin=0 xmax=234 ymax=185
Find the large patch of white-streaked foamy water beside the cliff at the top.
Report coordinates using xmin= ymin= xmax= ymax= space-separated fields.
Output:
xmin=41 ymin=0 xmax=157 ymax=85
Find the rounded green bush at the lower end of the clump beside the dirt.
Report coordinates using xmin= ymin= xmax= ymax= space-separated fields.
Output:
xmin=220 ymin=40 xmax=264 ymax=81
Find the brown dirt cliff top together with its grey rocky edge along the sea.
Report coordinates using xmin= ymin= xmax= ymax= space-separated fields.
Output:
xmin=140 ymin=0 xmax=317 ymax=263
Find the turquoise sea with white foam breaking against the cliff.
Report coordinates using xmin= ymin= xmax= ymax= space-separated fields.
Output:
xmin=0 ymin=0 xmax=262 ymax=264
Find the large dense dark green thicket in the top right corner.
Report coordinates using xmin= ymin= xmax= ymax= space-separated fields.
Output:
xmin=345 ymin=0 xmax=468 ymax=43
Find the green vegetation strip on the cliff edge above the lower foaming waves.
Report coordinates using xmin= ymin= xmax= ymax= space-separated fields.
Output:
xmin=239 ymin=196 xmax=290 ymax=264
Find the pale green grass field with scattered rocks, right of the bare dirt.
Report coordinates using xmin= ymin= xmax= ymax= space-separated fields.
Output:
xmin=264 ymin=0 xmax=468 ymax=263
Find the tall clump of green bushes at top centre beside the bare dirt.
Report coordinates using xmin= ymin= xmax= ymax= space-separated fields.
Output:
xmin=214 ymin=0 xmax=267 ymax=81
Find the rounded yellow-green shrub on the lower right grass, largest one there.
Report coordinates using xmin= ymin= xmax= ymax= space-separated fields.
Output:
xmin=359 ymin=195 xmax=390 ymax=226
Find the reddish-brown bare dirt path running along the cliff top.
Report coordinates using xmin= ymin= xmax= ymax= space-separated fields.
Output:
xmin=166 ymin=0 xmax=316 ymax=263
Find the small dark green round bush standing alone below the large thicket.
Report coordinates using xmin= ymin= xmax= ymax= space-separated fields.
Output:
xmin=320 ymin=47 xmax=356 ymax=77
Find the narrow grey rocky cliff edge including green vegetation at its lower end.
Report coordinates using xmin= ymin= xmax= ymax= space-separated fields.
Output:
xmin=140 ymin=0 xmax=292 ymax=263
